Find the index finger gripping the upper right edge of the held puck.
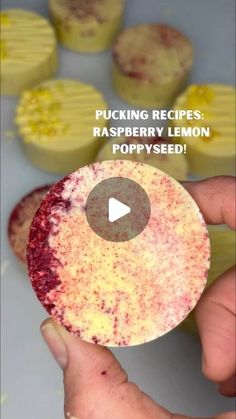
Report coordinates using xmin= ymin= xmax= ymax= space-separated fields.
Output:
xmin=183 ymin=176 xmax=236 ymax=230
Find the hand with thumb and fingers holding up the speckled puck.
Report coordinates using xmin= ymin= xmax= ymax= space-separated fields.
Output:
xmin=41 ymin=177 xmax=236 ymax=419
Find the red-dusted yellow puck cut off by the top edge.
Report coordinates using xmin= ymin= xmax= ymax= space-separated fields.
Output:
xmin=49 ymin=0 xmax=125 ymax=52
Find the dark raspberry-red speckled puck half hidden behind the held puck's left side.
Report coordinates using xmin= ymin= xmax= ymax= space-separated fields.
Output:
xmin=8 ymin=185 xmax=52 ymax=264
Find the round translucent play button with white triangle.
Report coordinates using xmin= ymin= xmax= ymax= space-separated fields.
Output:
xmin=85 ymin=177 xmax=151 ymax=242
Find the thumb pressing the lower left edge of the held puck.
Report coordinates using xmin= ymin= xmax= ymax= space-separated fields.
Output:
xmin=41 ymin=319 xmax=171 ymax=419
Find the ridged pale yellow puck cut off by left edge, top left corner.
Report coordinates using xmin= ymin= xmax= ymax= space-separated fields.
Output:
xmin=1 ymin=9 xmax=57 ymax=96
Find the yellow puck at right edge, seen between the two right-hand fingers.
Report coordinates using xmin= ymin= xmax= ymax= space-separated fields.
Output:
xmin=181 ymin=226 xmax=236 ymax=332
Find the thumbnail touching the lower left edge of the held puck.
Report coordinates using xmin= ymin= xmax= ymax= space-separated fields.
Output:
xmin=41 ymin=322 xmax=67 ymax=369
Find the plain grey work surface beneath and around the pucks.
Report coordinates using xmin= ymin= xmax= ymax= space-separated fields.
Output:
xmin=1 ymin=0 xmax=234 ymax=419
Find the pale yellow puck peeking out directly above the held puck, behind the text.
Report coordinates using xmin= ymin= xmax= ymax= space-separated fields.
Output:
xmin=96 ymin=137 xmax=188 ymax=180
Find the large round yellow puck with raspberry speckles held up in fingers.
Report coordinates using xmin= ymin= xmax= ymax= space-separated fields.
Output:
xmin=27 ymin=160 xmax=210 ymax=346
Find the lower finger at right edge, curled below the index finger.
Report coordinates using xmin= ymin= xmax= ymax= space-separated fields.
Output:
xmin=195 ymin=268 xmax=236 ymax=395
